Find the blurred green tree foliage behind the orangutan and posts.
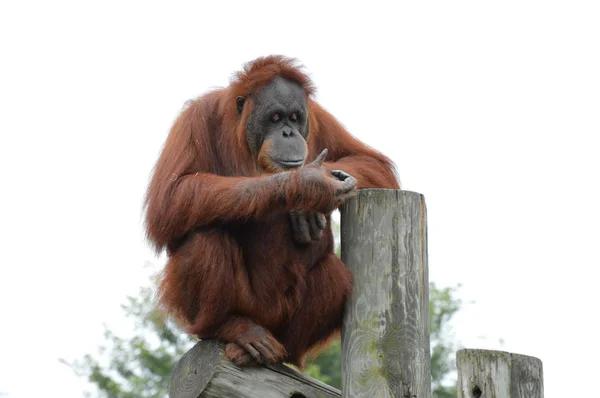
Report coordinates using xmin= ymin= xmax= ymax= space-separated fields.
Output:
xmin=63 ymin=284 xmax=460 ymax=398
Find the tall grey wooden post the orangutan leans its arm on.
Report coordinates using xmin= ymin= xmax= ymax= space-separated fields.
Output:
xmin=341 ymin=189 xmax=431 ymax=398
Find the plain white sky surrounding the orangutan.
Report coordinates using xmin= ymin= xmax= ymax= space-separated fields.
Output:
xmin=0 ymin=0 xmax=600 ymax=398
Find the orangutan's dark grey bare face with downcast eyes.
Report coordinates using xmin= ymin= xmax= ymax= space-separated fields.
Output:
xmin=243 ymin=77 xmax=308 ymax=172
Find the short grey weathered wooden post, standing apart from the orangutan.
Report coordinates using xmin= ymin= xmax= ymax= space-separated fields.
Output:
xmin=456 ymin=350 xmax=544 ymax=398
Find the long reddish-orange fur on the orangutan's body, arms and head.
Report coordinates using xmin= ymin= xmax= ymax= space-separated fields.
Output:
xmin=145 ymin=56 xmax=399 ymax=364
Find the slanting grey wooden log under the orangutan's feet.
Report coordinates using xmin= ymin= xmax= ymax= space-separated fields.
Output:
xmin=169 ymin=340 xmax=340 ymax=398
